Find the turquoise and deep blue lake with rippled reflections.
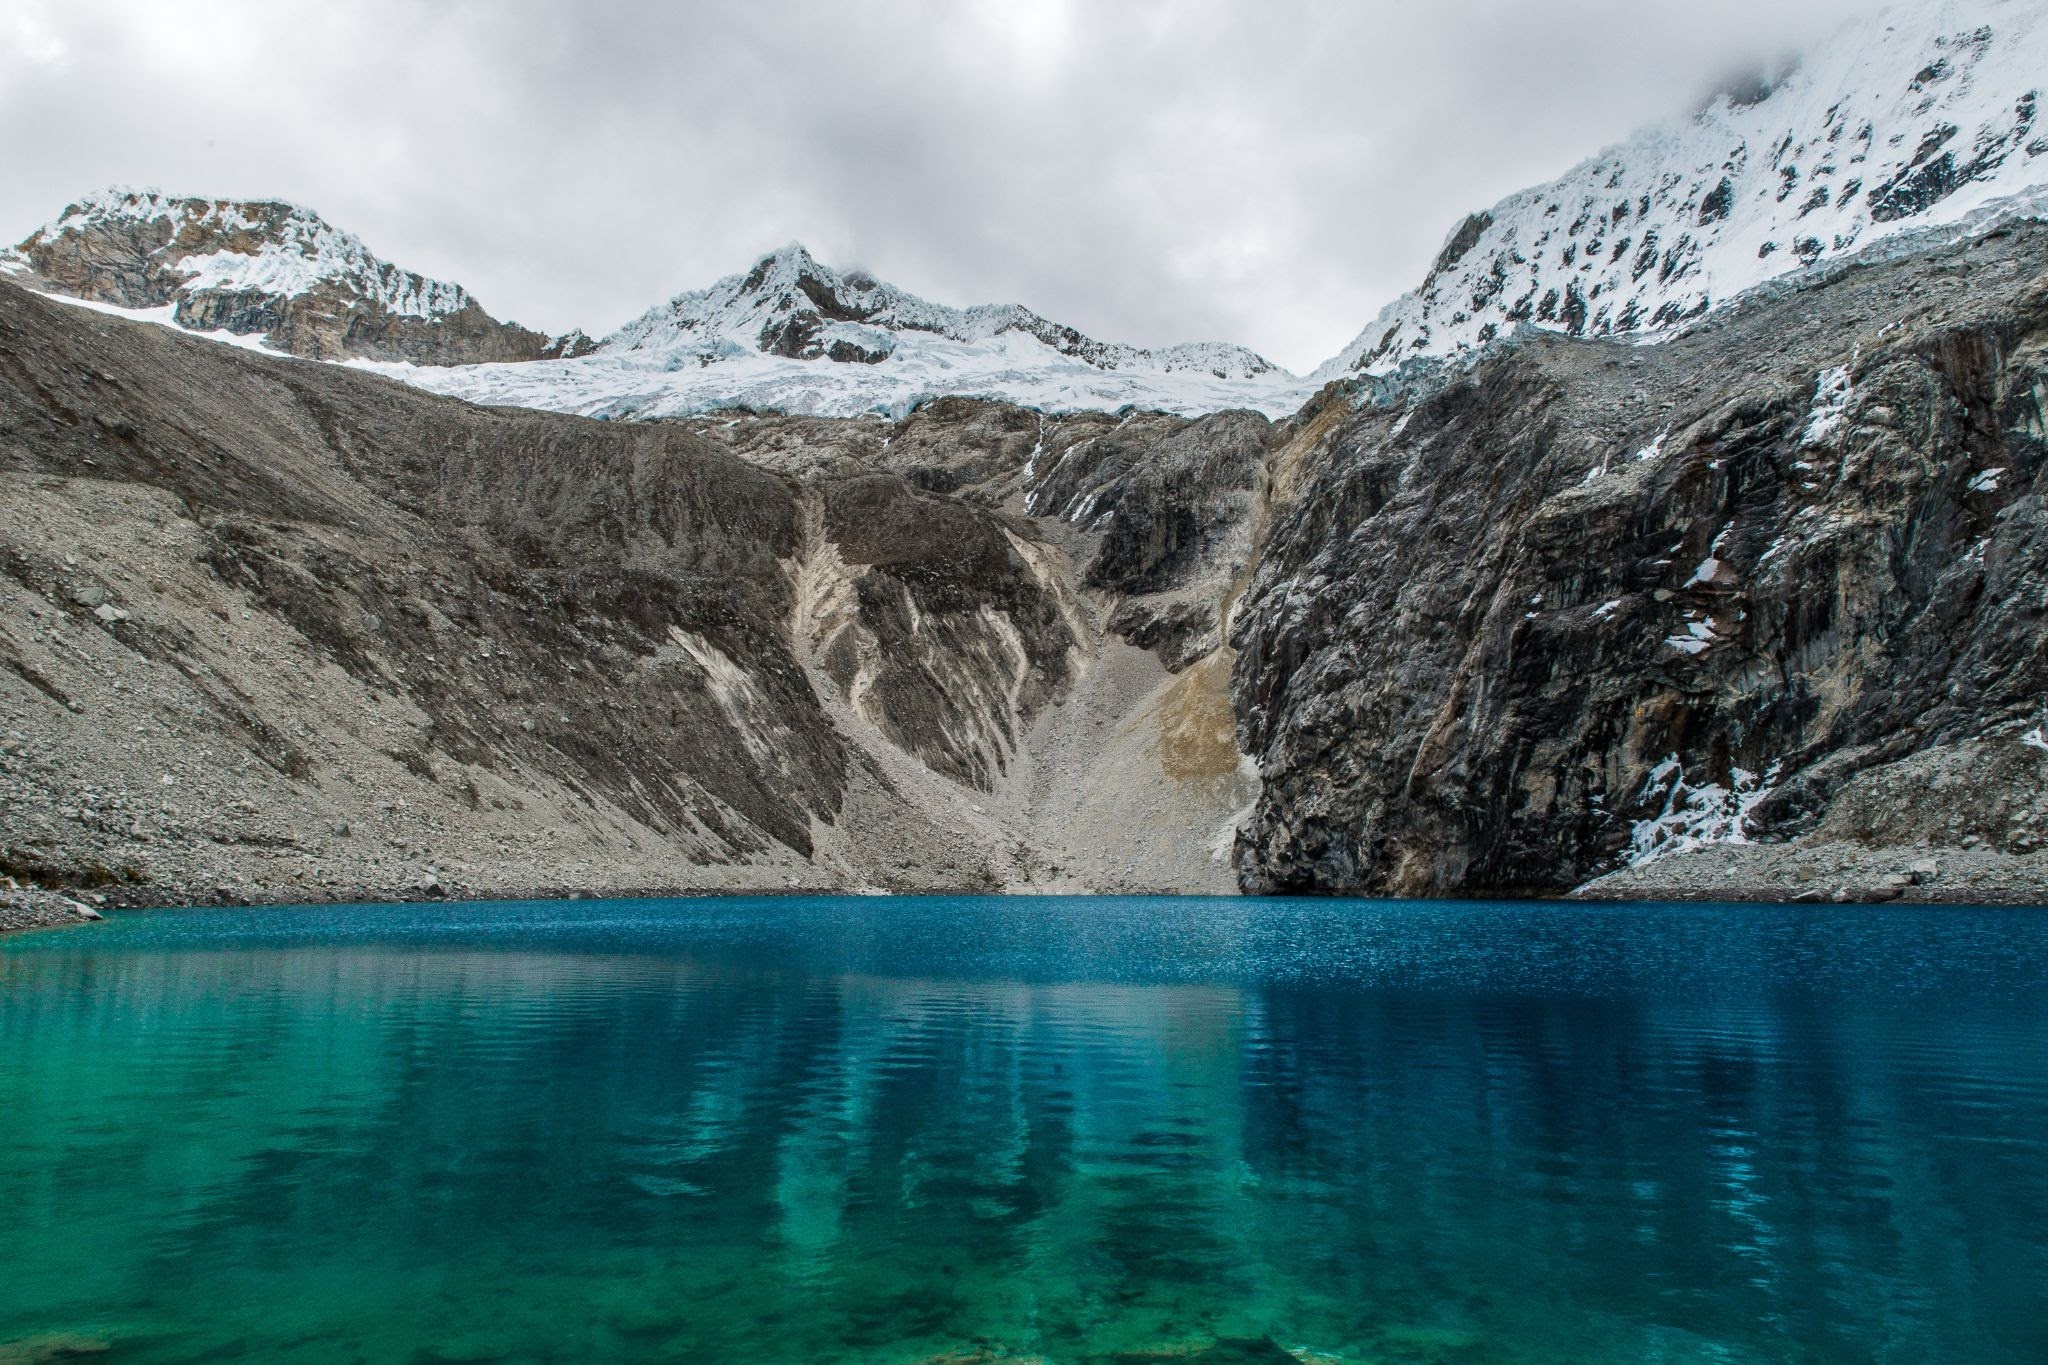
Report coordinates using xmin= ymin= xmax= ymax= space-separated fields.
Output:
xmin=0 ymin=898 xmax=2048 ymax=1365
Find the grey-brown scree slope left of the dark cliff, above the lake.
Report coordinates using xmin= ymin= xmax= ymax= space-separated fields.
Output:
xmin=0 ymin=284 xmax=1268 ymax=900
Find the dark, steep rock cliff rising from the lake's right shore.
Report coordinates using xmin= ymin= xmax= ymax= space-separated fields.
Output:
xmin=1233 ymin=227 xmax=2048 ymax=894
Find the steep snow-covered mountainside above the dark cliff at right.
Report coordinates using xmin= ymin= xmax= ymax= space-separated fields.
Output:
xmin=1315 ymin=0 xmax=2048 ymax=379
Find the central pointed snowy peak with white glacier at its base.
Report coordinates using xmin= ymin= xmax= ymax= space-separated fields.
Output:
xmin=366 ymin=244 xmax=1311 ymax=417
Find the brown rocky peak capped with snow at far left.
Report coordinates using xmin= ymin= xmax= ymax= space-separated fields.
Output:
xmin=0 ymin=188 xmax=588 ymax=364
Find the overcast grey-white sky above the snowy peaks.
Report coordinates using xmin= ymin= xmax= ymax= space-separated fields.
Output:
xmin=0 ymin=0 xmax=1875 ymax=370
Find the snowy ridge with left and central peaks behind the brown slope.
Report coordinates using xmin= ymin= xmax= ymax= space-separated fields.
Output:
xmin=0 ymin=188 xmax=1311 ymax=417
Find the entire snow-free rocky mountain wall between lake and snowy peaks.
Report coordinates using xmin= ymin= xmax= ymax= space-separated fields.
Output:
xmin=19 ymin=210 xmax=2048 ymax=905
